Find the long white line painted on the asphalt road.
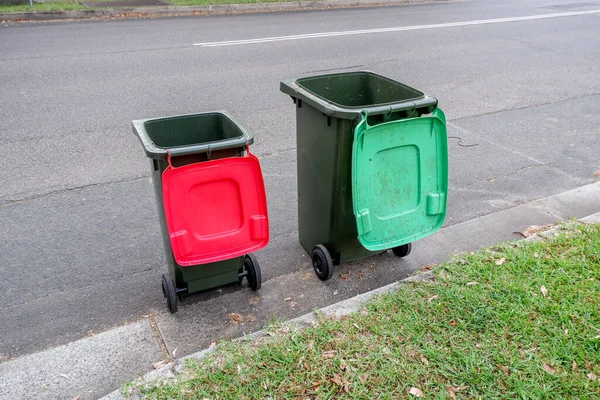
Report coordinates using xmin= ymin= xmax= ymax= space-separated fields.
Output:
xmin=193 ymin=10 xmax=600 ymax=47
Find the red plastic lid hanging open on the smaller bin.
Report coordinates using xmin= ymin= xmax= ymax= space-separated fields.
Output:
xmin=162 ymin=152 xmax=269 ymax=267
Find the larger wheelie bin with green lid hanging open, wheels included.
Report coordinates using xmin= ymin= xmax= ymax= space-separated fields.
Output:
xmin=280 ymin=71 xmax=448 ymax=280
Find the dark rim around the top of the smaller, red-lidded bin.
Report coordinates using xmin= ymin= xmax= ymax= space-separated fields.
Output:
xmin=131 ymin=110 xmax=254 ymax=160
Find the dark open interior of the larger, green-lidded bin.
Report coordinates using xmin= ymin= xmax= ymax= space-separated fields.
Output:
xmin=296 ymin=72 xmax=424 ymax=107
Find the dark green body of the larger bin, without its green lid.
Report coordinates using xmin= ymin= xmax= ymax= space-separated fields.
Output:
xmin=280 ymin=71 xmax=437 ymax=264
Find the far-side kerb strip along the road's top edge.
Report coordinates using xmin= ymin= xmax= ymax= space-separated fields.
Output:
xmin=0 ymin=0 xmax=450 ymax=22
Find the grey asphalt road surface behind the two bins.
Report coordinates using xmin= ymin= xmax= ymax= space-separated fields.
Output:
xmin=0 ymin=0 xmax=600 ymax=361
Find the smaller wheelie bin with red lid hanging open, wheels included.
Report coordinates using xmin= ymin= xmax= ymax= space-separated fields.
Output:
xmin=132 ymin=111 xmax=269 ymax=313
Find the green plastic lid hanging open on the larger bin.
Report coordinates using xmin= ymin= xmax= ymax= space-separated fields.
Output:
xmin=352 ymin=109 xmax=448 ymax=251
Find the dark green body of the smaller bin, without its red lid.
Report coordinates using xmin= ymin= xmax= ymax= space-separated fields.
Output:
xmin=132 ymin=111 xmax=253 ymax=296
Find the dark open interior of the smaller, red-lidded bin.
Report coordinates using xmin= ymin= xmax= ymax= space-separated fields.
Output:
xmin=144 ymin=113 xmax=244 ymax=149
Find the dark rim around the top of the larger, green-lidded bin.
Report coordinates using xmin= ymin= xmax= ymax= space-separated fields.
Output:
xmin=279 ymin=70 xmax=438 ymax=119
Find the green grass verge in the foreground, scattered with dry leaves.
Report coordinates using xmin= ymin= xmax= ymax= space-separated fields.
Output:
xmin=130 ymin=224 xmax=600 ymax=399
